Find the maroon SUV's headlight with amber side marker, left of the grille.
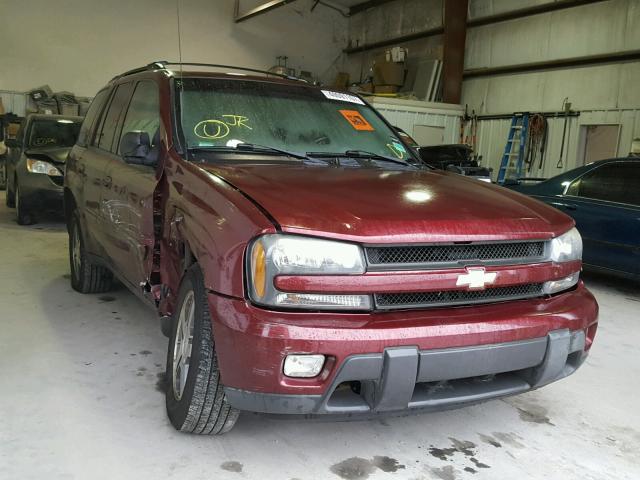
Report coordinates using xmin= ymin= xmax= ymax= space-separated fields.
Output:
xmin=248 ymin=234 xmax=371 ymax=310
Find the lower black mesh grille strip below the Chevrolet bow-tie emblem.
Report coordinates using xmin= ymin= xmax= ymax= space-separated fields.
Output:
xmin=374 ymin=283 xmax=543 ymax=310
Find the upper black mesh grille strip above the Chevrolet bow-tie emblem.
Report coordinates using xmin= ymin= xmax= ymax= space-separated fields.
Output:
xmin=365 ymin=241 xmax=545 ymax=270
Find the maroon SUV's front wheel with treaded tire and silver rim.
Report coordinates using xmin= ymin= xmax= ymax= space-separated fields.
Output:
xmin=165 ymin=264 xmax=240 ymax=435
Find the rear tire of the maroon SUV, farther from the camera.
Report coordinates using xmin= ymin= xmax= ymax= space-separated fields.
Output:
xmin=69 ymin=212 xmax=113 ymax=293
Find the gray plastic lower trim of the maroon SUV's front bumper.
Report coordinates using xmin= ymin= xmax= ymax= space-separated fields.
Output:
xmin=225 ymin=330 xmax=586 ymax=415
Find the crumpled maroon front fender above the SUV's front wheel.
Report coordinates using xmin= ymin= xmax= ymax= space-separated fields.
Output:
xmin=161 ymin=158 xmax=276 ymax=316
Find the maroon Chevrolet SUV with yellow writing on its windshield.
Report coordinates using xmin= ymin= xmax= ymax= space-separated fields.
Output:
xmin=65 ymin=62 xmax=598 ymax=434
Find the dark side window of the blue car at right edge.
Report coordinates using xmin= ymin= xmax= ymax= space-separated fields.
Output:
xmin=567 ymin=162 xmax=640 ymax=206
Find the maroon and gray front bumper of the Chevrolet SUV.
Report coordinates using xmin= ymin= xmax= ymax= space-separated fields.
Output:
xmin=209 ymin=283 xmax=598 ymax=415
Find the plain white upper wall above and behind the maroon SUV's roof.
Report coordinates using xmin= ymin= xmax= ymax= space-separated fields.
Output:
xmin=0 ymin=0 xmax=348 ymax=96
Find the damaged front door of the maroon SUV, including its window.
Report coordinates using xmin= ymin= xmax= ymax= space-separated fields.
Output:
xmin=103 ymin=80 xmax=160 ymax=288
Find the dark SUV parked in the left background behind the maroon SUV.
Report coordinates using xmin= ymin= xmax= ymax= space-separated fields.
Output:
xmin=5 ymin=114 xmax=82 ymax=225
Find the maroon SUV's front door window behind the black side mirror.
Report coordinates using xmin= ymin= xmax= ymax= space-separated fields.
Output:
xmin=118 ymin=80 xmax=160 ymax=155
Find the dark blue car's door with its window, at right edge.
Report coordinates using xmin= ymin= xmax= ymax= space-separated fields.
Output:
xmin=561 ymin=160 xmax=640 ymax=275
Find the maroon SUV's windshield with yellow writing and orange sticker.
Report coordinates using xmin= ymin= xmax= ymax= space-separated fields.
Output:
xmin=176 ymin=78 xmax=409 ymax=160
